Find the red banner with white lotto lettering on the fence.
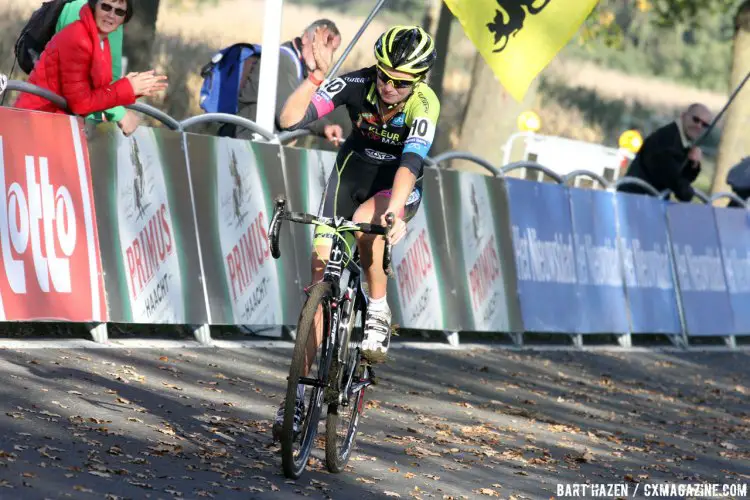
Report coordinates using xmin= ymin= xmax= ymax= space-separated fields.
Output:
xmin=0 ymin=108 xmax=107 ymax=322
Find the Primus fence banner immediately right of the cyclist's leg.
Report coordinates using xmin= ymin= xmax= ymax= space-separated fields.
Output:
xmin=388 ymin=168 xmax=460 ymax=331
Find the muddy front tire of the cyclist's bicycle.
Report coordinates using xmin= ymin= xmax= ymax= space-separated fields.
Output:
xmin=281 ymin=282 xmax=332 ymax=479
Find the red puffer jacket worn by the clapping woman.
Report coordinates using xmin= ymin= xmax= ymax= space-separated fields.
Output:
xmin=14 ymin=4 xmax=136 ymax=116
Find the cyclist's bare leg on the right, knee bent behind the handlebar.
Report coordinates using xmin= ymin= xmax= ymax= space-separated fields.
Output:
xmin=352 ymin=196 xmax=390 ymax=300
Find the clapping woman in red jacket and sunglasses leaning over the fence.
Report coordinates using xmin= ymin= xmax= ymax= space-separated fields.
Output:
xmin=15 ymin=0 xmax=167 ymax=116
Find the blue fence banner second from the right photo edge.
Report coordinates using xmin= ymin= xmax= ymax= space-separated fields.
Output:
xmin=667 ymin=203 xmax=734 ymax=335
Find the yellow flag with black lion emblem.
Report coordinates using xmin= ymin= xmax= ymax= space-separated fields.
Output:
xmin=445 ymin=0 xmax=598 ymax=102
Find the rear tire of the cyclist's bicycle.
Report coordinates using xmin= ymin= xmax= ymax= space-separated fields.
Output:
xmin=326 ymin=308 xmax=369 ymax=473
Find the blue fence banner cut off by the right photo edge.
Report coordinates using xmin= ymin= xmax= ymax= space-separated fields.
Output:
xmin=714 ymin=208 xmax=750 ymax=335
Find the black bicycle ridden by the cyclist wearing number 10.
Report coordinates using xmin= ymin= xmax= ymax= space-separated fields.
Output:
xmin=268 ymin=197 xmax=394 ymax=479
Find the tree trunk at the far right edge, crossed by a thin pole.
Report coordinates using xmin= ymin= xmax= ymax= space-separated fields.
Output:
xmin=711 ymin=0 xmax=750 ymax=198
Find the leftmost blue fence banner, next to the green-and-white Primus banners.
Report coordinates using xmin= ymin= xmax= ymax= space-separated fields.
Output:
xmin=506 ymin=178 xmax=581 ymax=333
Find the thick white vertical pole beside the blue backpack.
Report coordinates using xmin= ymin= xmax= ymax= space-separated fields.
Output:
xmin=255 ymin=0 xmax=284 ymax=140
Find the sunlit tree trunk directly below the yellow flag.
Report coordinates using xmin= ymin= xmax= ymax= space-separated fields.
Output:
xmin=452 ymin=52 xmax=537 ymax=174
